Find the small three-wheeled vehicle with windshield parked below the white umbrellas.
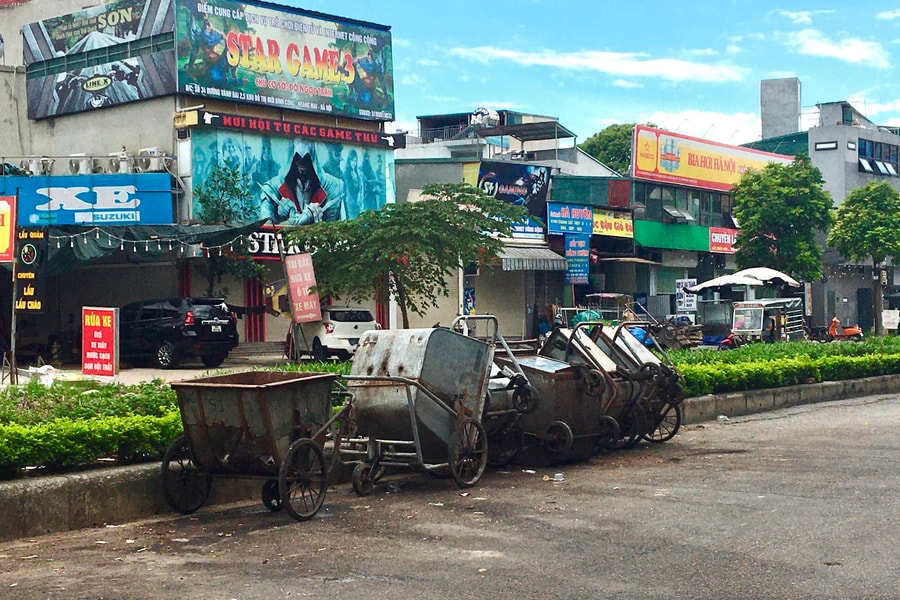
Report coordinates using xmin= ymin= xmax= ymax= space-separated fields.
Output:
xmin=731 ymin=298 xmax=804 ymax=342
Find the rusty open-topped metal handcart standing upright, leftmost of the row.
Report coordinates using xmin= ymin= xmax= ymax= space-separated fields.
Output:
xmin=162 ymin=371 xmax=350 ymax=521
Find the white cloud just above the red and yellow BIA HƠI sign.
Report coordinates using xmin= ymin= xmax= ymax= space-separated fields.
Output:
xmin=640 ymin=110 xmax=762 ymax=146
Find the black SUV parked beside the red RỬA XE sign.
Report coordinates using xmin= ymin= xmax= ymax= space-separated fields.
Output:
xmin=119 ymin=298 xmax=238 ymax=369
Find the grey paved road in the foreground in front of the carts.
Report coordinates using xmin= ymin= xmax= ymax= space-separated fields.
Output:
xmin=0 ymin=395 xmax=900 ymax=600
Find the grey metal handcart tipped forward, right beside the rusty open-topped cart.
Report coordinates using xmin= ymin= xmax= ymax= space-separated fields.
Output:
xmin=340 ymin=328 xmax=494 ymax=496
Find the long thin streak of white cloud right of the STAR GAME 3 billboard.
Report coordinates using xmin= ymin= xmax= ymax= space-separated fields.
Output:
xmin=450 ymin=46 xmax=750 ymax=83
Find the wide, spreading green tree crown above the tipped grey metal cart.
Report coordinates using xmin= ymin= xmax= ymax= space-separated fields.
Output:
xmin=285 ymin=184 xmax=527 ymax=328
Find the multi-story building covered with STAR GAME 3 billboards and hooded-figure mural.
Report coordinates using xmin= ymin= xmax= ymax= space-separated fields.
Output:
xmin=0 ymin=0 xmax=395 ymax=356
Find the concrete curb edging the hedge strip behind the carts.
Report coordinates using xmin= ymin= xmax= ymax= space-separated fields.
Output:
xmin=0 ymin=375 xmax=900 ymax=542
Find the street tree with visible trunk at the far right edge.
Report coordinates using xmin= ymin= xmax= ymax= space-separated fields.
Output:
xmin=827 ymin=181 xmax=900 ymax=335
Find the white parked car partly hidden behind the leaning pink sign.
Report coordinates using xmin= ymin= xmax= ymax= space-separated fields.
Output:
xmin=288 ymin=306 xmax=380 ymax=361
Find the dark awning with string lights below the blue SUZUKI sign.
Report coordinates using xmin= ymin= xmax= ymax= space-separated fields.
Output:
xmin=7 ymin=220 xmax=267 ymax=275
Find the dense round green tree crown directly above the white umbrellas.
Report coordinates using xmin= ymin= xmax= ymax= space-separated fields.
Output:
xmin=732 ymin=155 xmax=832 ymax=281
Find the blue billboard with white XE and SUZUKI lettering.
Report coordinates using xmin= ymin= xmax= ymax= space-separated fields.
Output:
xmin=0 ymin=173 xmax=174 ymax=227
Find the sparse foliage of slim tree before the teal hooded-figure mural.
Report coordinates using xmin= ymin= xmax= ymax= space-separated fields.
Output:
xmin=194 ymin=163 xmax=263 ymax=297
